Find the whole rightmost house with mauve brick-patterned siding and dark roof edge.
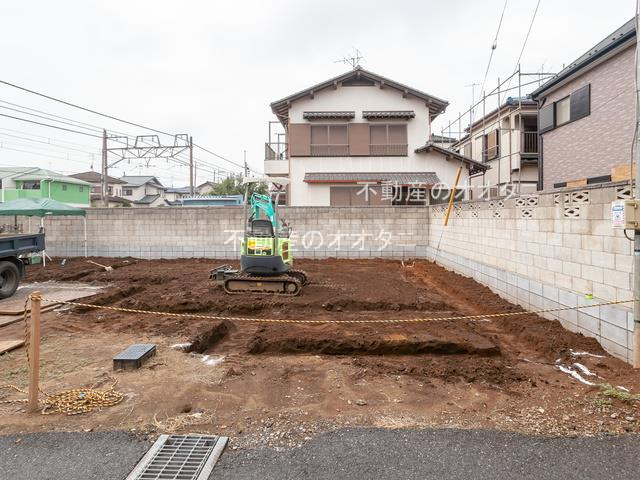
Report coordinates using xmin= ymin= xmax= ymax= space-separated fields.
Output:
xmin=533 ymin=19 xmax=636 ymax=190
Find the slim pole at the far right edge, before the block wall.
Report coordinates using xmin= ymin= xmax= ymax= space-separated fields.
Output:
xmin=632 ymin=0 xmax=640 ymax=368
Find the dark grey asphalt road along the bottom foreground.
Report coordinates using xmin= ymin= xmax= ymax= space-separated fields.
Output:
xmin=0 ymin=429 xmax=640 ymax=480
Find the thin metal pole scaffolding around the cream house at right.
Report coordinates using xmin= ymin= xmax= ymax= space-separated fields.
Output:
xmin=433 ymin=65 xmax=555 ymax=198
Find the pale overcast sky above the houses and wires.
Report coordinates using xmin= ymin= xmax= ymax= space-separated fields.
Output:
xmin=0 ymin=0 xmax=635 ymax=186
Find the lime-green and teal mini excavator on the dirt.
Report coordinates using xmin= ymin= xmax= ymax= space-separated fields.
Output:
xmin=209 ymin=177 xmax=307 ymax=296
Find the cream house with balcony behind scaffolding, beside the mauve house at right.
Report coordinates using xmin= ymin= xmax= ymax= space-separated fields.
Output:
xmin=453 ymin=97 xmax=539 ymax=198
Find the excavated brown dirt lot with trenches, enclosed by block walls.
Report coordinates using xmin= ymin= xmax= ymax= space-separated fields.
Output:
xmin=0 ymin=258 xmax=640 ymax=447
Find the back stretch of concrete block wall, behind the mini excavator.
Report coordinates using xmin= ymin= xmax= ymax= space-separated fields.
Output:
xmin=35 ymin=207 xmax=428 ymax=259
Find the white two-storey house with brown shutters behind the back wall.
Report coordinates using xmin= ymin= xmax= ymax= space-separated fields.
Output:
xmin=264 ymin=67 xmax=486 ymax=206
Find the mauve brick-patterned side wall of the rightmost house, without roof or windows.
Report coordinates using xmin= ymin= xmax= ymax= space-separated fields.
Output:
xmin=542 ymin=46 xmax=635 ymax=190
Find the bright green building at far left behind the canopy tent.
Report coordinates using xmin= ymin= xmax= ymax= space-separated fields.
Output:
xmin=0 ymin=167 xmax=91 ymax=207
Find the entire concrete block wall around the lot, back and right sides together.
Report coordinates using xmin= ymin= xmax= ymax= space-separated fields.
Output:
xmin=33 ymin=185 xmax=633 ymax=361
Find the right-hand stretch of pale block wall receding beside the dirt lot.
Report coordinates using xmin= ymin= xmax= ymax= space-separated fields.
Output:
xmin=427 ymin=185 xmax=633 ymax=361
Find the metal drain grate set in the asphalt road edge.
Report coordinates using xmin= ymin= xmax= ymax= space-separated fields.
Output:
xmin=126 ymin=435 xmax=229 ymax=480
